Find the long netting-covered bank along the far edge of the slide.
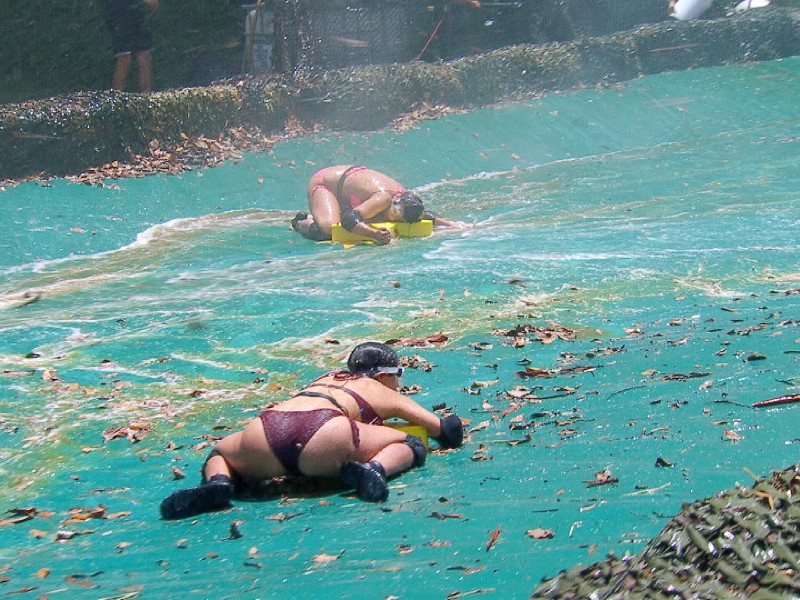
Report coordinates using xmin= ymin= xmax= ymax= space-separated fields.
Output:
xmin=0 ymin=8 xmax=800 ymax=180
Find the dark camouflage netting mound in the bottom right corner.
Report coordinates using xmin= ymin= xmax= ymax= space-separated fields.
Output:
xmin=531 ymin=463 xmax=800 ymax=600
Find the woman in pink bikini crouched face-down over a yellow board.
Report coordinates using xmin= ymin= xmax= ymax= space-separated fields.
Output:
xmin=292 ymin=165 xmax=461 ymax=244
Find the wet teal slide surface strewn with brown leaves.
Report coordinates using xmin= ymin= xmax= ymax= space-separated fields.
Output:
xmin=0 ymin=58 xmax=800 ymax=598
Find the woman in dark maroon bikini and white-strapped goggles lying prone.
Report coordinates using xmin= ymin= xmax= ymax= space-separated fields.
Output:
xmin=161 ymin=342 xmax=464 ymax=519
